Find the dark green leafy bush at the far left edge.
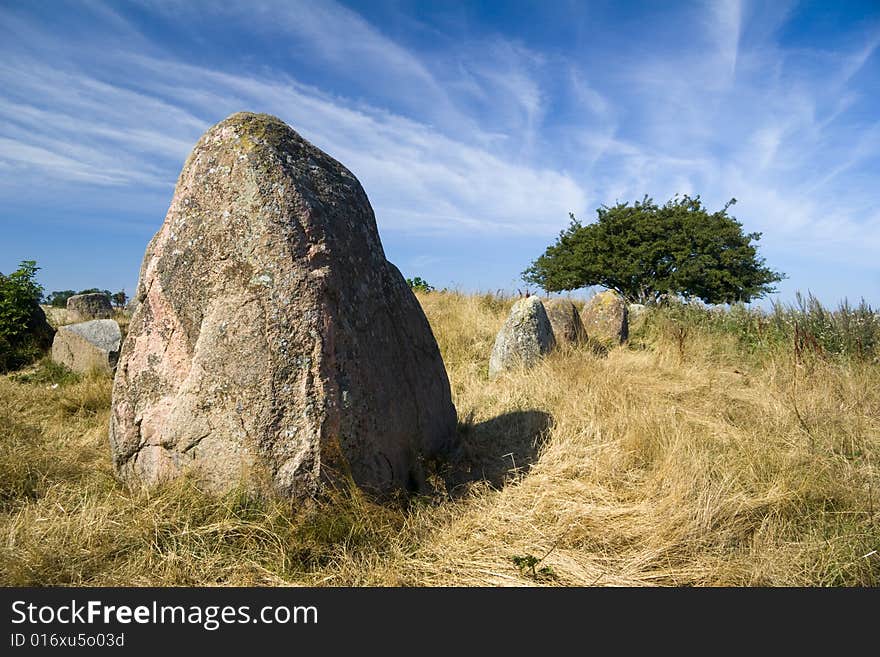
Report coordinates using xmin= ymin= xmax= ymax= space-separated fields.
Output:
xmin=0 ymin=260 xmax=43 ymax=371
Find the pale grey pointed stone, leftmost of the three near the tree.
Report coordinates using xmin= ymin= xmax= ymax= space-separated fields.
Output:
xmin=489 ymin=297 xmax=556 ymax=378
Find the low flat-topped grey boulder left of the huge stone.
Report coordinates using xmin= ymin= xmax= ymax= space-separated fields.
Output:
xmin=52 ymin=319 xmax=122 ymax=374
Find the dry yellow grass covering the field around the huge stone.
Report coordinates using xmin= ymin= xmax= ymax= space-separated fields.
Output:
xmin=0 ymin=292 xmax=880 ymax=586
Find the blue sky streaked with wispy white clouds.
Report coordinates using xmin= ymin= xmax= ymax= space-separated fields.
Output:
xmin=0 ymin=0 xmax=880 ymax=306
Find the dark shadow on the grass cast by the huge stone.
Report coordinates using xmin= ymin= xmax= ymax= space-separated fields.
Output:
xmin=434 ymin=410 xmax=553 ymax=497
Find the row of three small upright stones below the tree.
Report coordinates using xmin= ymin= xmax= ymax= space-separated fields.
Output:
xmin=489 ymin=290 xmax=630 ymax=378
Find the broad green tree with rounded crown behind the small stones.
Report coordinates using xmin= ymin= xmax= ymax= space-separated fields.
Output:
xmin=522 ymin=196 xmax=785 ymax=303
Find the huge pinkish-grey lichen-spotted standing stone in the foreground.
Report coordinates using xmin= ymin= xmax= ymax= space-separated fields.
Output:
xmin=110 ymin=113 xmax=456 ymax=497
